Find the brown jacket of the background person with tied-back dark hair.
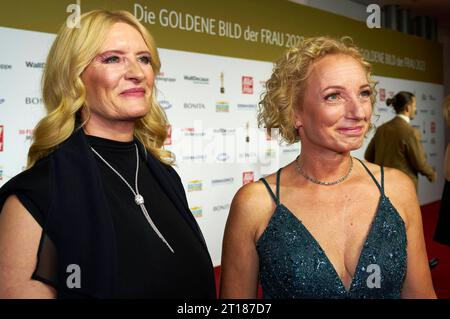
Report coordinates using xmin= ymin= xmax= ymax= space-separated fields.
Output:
xmin=364 ymin=116 xmax=434 ymax=189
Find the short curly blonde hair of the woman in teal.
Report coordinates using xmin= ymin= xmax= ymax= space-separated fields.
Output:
xmin=258 ymin=37 xmax=375 ymax=144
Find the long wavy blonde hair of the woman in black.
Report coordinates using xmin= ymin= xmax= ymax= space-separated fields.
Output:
xmin=27 ymin=10 xmax=174 ymax=168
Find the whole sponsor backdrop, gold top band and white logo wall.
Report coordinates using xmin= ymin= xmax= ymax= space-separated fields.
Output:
xmin=0 ymin=0 xmax=444 ymax=265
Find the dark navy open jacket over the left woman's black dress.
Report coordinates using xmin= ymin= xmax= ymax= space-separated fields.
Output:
xmin=0 ymin=129 xmax=216 ymax=298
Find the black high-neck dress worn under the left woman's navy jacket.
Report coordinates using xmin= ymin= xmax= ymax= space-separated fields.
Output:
xmin=0 ymin=136 xmax=215 ymax=298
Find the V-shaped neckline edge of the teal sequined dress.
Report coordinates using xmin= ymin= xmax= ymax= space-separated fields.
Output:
xmin=280 ymin=194 xmax=384 ymax=294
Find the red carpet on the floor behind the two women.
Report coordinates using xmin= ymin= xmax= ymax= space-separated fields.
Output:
xmin=214 ymin=201 xmax=450 ymax=299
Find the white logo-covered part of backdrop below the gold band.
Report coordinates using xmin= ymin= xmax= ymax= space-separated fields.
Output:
xmin=0 ymin=1 xmax=444 ymax=265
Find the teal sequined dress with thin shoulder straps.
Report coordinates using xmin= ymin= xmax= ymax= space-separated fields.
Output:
xmin=257 ymin=162 xmax=407 ymax=299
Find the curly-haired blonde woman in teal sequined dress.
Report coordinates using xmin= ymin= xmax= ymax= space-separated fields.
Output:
xmin=220 ymin=37 xmax=436 ymax=299
